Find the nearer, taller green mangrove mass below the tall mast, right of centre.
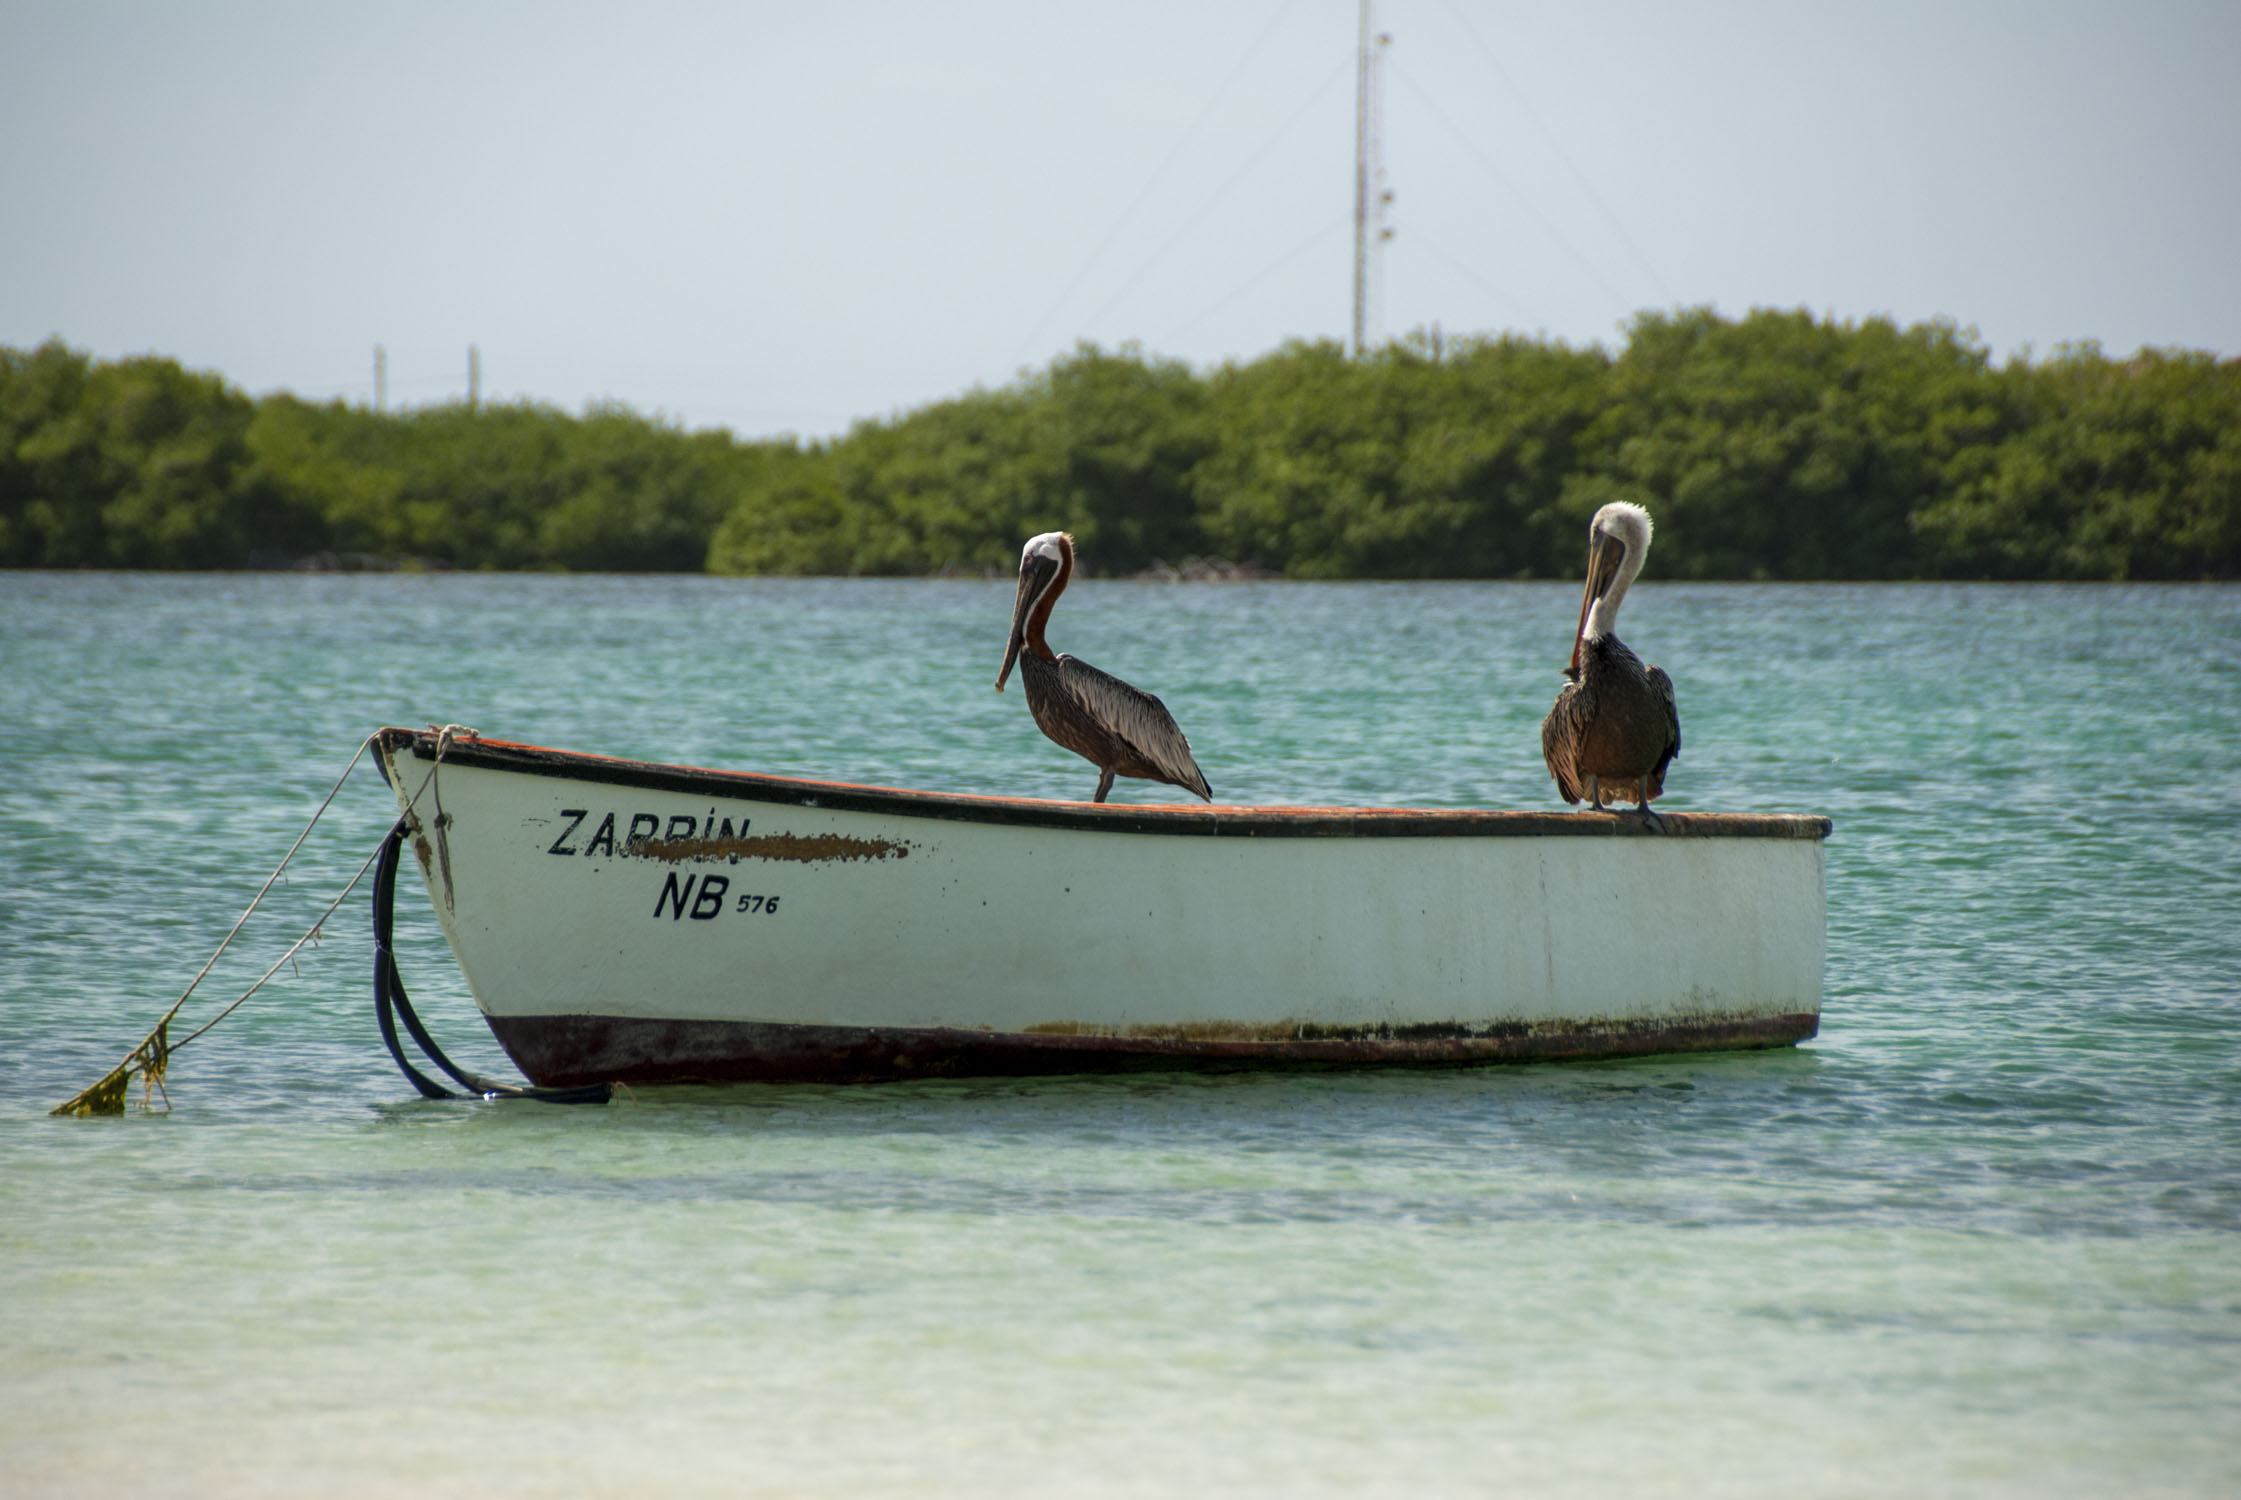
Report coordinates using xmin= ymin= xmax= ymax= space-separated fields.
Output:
xmin=710 ymin=309 xmax=2241 ymax=578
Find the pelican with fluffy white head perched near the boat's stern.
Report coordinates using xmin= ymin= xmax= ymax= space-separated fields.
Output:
xmin=1542 ymin=500 xmax=1681 ymax=823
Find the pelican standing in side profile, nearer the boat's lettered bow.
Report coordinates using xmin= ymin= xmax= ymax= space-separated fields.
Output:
xmin=995 ymin=531 xmax=1215 ymax=803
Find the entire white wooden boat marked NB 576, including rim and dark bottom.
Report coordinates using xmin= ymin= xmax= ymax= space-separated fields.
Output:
xmin=379 ymin=731 xmax=1829 ymax=1083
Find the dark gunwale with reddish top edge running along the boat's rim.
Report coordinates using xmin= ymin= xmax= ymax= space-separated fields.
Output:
xmin=374 ymin=726 xmax=1831 ymax=841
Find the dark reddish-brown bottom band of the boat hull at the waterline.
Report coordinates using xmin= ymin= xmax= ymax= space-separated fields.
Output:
xmin=486 ymin=1011 xmax=1820 ymax=1085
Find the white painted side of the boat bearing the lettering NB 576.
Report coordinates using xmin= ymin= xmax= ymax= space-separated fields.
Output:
xmin=383 ymin=735 xmax=1826 ymax=1036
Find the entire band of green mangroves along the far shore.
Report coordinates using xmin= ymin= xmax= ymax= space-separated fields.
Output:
xmin=0 ymin=309 xmax=2241 ymax=578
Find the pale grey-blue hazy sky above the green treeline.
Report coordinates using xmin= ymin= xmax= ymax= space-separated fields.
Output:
xmin=0 ymin=0 xmax=2241 ymax=435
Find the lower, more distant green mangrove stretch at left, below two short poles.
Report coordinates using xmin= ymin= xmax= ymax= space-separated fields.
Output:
xmin=0 ymin=343 xmax=796 ymax=572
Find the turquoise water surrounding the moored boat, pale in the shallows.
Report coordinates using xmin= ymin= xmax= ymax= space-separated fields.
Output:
xmin=0 ymin=574 xmax=2241 ymax=1496
